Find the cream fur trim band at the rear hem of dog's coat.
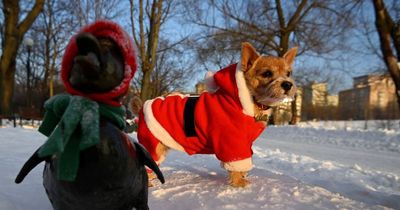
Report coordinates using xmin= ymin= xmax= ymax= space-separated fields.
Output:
xmin=143 ymin=96 xmax=185 ymax=152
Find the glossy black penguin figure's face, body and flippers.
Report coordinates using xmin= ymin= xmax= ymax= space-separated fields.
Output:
xmin=15 ymin=33 xmax=164 ymax=210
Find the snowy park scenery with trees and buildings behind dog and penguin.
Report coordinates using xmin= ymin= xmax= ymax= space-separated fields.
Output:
xmin=0 ymin=0 xmax=400 ymax=210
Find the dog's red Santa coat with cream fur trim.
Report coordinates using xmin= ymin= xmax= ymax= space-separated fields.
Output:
xmin=138 ymin=64 xmax=265 ymax=171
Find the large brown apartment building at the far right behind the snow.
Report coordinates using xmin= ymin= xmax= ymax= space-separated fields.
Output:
xmin=339 ymin=74 xmax=400 ymax=120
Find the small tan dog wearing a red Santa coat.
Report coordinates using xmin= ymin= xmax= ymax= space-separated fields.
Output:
xmin=138 ymin=42 xmax=297 ymax=187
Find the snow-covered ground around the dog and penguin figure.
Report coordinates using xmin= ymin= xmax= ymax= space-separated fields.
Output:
xmin=0 ymin=122 xmax=400 ymax=210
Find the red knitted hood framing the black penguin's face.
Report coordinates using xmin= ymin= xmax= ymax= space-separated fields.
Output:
xmin=61 ymin=20 xmax=137 ymax=106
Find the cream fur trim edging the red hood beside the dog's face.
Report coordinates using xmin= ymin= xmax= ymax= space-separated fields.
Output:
xmin=235 ymin=64 xmax=254 ymax=117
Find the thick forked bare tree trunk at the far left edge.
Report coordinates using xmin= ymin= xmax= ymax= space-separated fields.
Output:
xmin=0 ymin=0 xmax=44 ymax=114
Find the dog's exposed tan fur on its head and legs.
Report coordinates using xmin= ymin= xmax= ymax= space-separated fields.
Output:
xmin=148 ymin=42 xmax=297 ymax=187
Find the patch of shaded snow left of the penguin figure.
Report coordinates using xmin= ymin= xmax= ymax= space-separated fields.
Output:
xmin=0 ymin=128 xmax=52 ymax=210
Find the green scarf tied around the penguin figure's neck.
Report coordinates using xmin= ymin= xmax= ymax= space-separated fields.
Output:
xmin=38 ymin=94 xmax=125 ymax=181
